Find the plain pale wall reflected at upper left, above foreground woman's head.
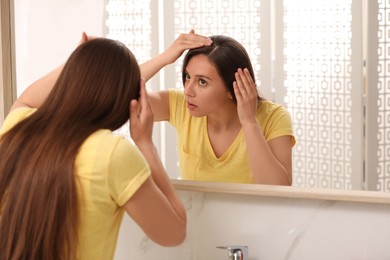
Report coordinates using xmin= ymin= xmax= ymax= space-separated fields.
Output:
xmin=14 ymin=0 xmax=105 ymax=96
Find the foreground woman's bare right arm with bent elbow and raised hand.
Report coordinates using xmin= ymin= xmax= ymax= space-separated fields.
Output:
xmin=125 ymin=81 xmax=187 ymax=246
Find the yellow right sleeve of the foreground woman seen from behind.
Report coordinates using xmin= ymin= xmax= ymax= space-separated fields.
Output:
xmin=107 ymin=139 xmax=150 ymax=206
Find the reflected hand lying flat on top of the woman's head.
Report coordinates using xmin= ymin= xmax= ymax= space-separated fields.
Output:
xmin=163 ymin=29 xmax=212 ymax=64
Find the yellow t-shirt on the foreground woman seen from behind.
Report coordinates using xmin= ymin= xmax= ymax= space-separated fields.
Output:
xmin=0 ymin=108 xmax=150 ymax=260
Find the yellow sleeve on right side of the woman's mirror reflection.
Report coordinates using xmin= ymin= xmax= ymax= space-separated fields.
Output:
xmin=265 ymin=106 xmax=296 ymax=146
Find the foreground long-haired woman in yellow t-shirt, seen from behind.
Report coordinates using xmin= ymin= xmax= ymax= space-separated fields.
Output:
xmin=0 ymin=34 xmax=210 ymax=260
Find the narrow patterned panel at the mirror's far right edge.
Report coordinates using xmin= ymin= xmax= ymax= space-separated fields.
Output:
xmin=365 ymin=0 xmax=390 ymax=191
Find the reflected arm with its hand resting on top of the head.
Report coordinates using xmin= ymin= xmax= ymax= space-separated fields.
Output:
xmin=140 ymin=30 xmax=212 ymax=121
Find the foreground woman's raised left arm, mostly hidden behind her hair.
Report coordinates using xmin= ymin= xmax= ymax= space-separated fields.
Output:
xmin=10 ymin=33 xmax=89 ymax=111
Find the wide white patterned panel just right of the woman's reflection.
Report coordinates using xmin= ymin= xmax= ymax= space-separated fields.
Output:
xmin=283 ymin=0 xmax=354 ymax=189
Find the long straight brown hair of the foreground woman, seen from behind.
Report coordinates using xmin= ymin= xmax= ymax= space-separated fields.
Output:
xmin=0 ymin=38 xmax=141 ymax=259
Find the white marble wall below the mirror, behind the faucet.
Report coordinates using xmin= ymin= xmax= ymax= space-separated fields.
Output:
xmin=115 ymin=191 xmax=390 ymax=260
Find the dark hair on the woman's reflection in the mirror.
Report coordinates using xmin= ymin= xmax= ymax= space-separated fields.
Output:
xmin=182 ymin=35 xmax=262 ymax=102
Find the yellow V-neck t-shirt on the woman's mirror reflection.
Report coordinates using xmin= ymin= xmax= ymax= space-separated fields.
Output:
xmin=169 ymin=89 xmax=295 ymax=183
